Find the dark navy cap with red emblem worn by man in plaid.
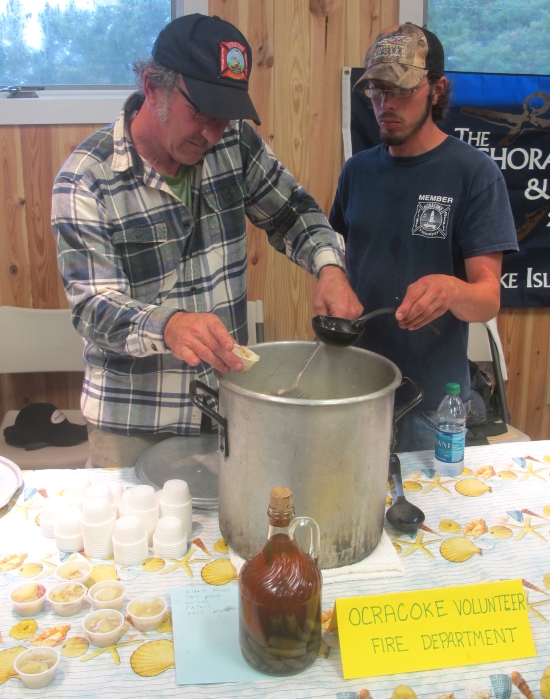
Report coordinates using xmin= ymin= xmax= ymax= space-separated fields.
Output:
xmin=152 ymin=14 xmax=260 ymax=124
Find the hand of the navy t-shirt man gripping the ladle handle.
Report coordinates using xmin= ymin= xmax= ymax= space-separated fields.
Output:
xmin=395 ymin=274 xmax=458 ymax=330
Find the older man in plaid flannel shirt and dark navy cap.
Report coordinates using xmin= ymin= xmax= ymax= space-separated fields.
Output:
xmin=52 ymin=15 xmax=362 ymax=466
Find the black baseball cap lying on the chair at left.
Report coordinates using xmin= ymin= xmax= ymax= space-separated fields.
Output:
xmin=4 ymin=403 xmax=88 ymax=451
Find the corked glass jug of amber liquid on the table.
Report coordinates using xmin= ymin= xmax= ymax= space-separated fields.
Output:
xmin=239 ymin=487 xmax=322 ymax=676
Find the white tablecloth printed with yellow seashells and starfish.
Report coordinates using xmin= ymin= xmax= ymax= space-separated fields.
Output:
xmin=0 ymin=441 xmax=550 ymax=699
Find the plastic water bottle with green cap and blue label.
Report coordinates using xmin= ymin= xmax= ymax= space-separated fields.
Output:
xmin=434 ymin=383 xmax=466 ymax=476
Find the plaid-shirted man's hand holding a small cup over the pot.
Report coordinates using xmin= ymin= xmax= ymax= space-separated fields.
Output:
xmin=164 ymin=312 xmax=243 ymax=372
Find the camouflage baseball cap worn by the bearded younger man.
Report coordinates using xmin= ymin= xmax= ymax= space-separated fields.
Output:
xmin=353 ymin=22 xmax=445 ymax=90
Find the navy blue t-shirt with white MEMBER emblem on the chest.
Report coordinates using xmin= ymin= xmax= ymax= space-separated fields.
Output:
xmin=329 ymin=136 xmax=518 ymax=410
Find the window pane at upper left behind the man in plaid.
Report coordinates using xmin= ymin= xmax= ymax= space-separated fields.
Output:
xmin=0 ymin=0 xmax=172 ymax=86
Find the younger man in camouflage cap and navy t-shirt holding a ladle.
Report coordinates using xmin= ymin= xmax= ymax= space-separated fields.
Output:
xmin=329 ymin=23 xmax=518 ymax=451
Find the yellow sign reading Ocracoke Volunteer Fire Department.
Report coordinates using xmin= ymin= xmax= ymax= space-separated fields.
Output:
xmin=331 ymin=580 xmax=536 ymax=680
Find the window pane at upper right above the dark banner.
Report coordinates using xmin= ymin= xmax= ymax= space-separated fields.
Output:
xmin=427 ymin=0 xmax=550 ymax=75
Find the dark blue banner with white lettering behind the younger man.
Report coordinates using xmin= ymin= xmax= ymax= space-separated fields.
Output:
xmin=350 ymin=68 xmax=550 ymax=306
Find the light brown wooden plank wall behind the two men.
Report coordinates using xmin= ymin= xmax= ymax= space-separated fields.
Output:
xmin=0 ymin=0 xmax=550 ymax=439
